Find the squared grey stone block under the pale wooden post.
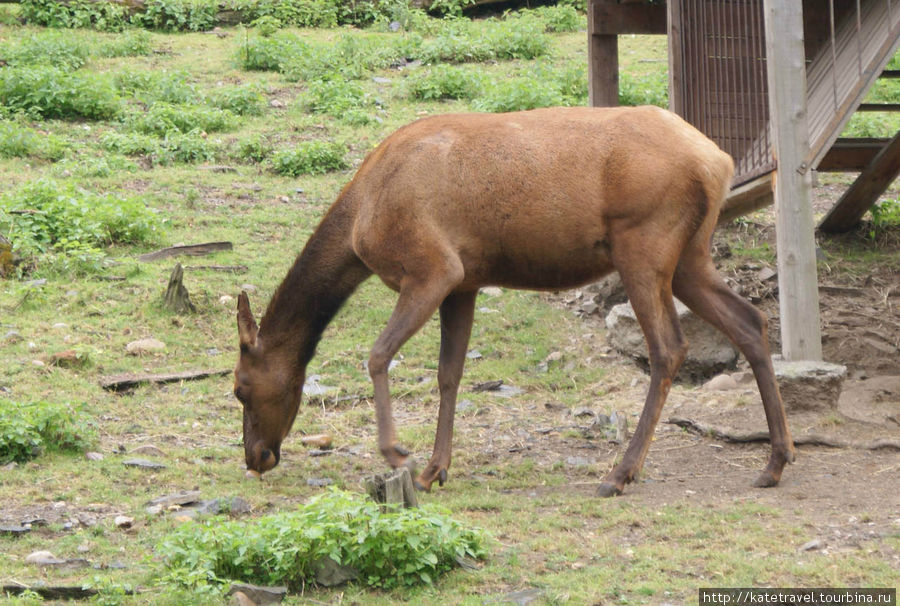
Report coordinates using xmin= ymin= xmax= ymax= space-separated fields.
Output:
xmin=772 ymin=356 xmax=847 ymax=412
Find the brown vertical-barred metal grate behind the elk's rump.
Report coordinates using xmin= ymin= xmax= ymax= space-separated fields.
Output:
xmin=674 ymin=0 xmax=775 ymax=185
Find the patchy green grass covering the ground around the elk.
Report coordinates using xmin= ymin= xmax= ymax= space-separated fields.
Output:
xmin=0 ymin=13 xmax=900 ymax=605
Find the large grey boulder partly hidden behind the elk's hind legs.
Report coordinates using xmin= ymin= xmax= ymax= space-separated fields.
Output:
xmin=606 ymin=300 xmax=738 ymax=381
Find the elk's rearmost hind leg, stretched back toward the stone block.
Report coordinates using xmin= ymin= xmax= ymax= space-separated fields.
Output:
xmin=672 ymin=253 xmax=794 ymax=487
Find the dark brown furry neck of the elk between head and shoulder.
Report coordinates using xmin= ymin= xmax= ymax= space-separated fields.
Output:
xmin=259 ymin=201 xmax=371 ymax=369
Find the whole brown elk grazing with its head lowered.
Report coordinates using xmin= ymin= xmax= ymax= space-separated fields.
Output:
xmin=234 ymin=107 xmax=794 ymax=496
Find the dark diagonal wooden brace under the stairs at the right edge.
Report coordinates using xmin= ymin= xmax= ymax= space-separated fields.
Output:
xmin=819 ymin=131 xmax=900 ymax=233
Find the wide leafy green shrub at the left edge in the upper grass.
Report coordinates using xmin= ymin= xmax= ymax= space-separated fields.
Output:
xmin=0 ymin=67 xmax=121 ymax=120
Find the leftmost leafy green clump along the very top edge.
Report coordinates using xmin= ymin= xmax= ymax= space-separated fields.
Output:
xmin=21 ymin=0 xmax=128 ymax=31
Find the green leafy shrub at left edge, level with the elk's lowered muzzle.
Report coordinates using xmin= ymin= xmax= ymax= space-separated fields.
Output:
xmin=0 ymin=398 xmax=93 ymax=465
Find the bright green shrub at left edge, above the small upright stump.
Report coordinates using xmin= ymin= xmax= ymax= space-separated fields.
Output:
xmin=0 ymin=179 xmax=162 ymax=254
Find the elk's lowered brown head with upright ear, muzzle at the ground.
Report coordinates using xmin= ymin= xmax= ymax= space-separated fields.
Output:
xmin=234 ymin=292 xmax=304 ymax=477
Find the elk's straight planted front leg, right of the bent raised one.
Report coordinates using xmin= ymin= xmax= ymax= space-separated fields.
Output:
xmin=415 ymin=291 xmax=478 ymax=491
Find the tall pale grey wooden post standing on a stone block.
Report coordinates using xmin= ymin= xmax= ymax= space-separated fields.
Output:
xmin=763 ymin=0 xmax=822 ymax=361
